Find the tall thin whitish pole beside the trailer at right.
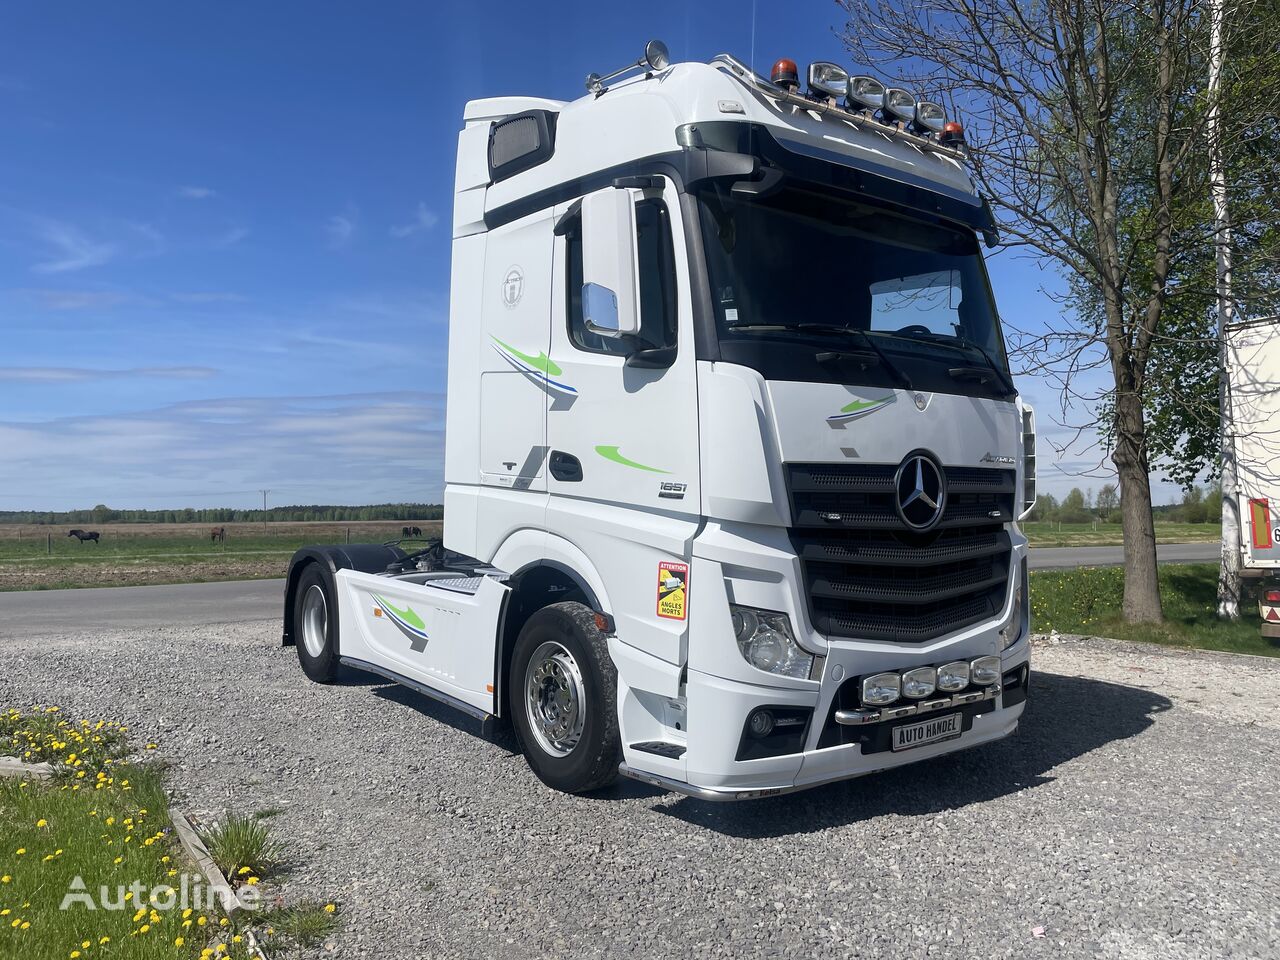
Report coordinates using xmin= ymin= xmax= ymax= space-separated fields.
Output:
xmin=1204 ymin=0 xmax=1240 ymax=620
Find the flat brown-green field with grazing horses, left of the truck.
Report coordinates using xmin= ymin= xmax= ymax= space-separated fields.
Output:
xmin=0 ymin=520 xmax=440 ymax=591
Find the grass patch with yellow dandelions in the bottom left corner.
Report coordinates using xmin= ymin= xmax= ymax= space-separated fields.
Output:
xmin=0 ymin=707 xmax=339 ymax=960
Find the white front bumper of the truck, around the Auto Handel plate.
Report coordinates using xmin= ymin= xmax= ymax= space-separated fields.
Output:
xmin=618 ymin=636 xmax=1030 ymax=801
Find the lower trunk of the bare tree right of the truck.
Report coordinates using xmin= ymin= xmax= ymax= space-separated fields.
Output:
xmin=1112 ymin=390 xmax=1165 ymax=623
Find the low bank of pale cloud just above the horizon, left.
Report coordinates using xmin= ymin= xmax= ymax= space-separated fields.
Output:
xmin=0 ymin=392 xmax=444 ymax=508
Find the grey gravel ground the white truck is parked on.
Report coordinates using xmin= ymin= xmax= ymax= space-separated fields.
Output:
xmin=0 ymin=619 xmax=1280 ymax=960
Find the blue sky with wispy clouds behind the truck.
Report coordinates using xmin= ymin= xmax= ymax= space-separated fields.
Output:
xmin=0 ymin=0 xmax=1167 ymax=509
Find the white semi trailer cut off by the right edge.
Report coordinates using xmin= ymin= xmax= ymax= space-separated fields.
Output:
xmin=1226 ymin=316 xmax=1280 ymax=637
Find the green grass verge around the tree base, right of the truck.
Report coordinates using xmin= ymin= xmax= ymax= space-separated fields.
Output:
xmin=1030 ymin=563 xmax=1280 ymax=657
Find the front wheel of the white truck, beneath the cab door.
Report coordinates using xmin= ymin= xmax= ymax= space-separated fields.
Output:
xmin=507 ymin=603 xmax=622 ymax=794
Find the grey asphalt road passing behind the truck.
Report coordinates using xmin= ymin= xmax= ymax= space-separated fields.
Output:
xmin=0 ymin=543 xmax=1220 ymax=637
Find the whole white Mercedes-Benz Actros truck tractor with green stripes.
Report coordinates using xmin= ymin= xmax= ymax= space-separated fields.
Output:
xmin=284 ymin=42 xmax=1034 ymax=800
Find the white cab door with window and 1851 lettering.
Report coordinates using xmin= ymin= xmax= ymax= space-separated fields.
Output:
xmin=547 ymin=184 xmax=700 ymax=663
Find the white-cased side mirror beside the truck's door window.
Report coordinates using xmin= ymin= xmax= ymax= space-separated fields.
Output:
xmin=582 ymin=187 xmax=640 ymax=337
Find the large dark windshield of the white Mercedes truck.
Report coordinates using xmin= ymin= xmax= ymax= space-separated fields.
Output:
xmin=700 ymin=184 xmax=1011 ymax=394
